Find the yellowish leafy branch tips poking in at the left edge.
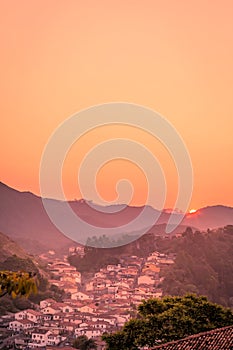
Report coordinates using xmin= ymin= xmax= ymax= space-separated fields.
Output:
xmin=0 ymin=271 xmax=37 ymax=298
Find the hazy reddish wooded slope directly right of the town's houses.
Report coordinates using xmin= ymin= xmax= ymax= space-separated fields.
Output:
xmin=157 ymin=225 xmax=233 ymax=307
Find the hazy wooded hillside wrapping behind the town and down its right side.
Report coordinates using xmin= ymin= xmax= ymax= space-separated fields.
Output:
xmin=69 ymin=225 xmax=233 ymax=307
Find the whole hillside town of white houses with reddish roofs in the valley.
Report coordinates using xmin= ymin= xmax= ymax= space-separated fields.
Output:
xmin=0 ymin=247 xmax=175 ymax=350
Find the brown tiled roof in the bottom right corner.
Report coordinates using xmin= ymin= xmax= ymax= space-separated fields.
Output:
xmin=151 ymin=326 xmax=233 ymax=350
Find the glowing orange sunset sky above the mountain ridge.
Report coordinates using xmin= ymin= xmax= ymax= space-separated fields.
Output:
xmin=0 ymin=0 xmax=233 ymax=208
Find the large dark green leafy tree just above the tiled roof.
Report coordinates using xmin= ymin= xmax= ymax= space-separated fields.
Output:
xmin=103 ymin=294 xmax=233 ymax=350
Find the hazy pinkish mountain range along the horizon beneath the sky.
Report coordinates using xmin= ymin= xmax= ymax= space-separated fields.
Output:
xmin=0 ymin=183 xmax=233 ymax=254
